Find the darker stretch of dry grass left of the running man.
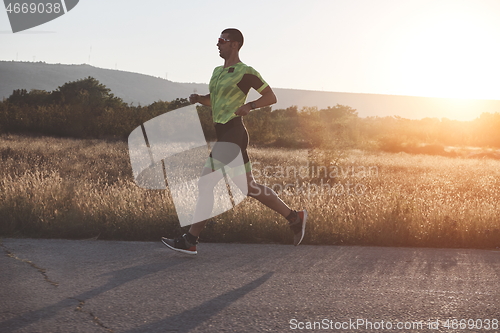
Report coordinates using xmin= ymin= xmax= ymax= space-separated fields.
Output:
xmin=0 ymin=136 xmax=179 ymax=239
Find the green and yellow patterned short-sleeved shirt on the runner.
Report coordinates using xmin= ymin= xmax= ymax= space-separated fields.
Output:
xmin=208 ymin=62 xmax=268 ymax=124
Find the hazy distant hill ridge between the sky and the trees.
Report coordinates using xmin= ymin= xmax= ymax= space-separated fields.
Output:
xmin=0 ymin=61 xmax=500 ymax=119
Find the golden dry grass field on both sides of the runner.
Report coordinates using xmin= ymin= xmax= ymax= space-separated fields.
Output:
xmin=0 ymin=135 xmax=500 ymax=248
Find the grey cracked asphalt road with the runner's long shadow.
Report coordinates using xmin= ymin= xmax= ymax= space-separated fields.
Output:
xmin=0 ymin=239 xmax=500 ymax=333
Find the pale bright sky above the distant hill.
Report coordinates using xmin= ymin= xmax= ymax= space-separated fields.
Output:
xmin=0 ymin=0 xmax=500 ymax=105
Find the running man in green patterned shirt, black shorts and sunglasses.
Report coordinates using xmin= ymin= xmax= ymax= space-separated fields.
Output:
xmin=162 ymin=29 xmax=307 ymax=254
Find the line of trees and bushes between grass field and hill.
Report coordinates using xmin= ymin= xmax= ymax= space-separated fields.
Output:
xmin=0 ymin=77 xmax=500 ymax=151
